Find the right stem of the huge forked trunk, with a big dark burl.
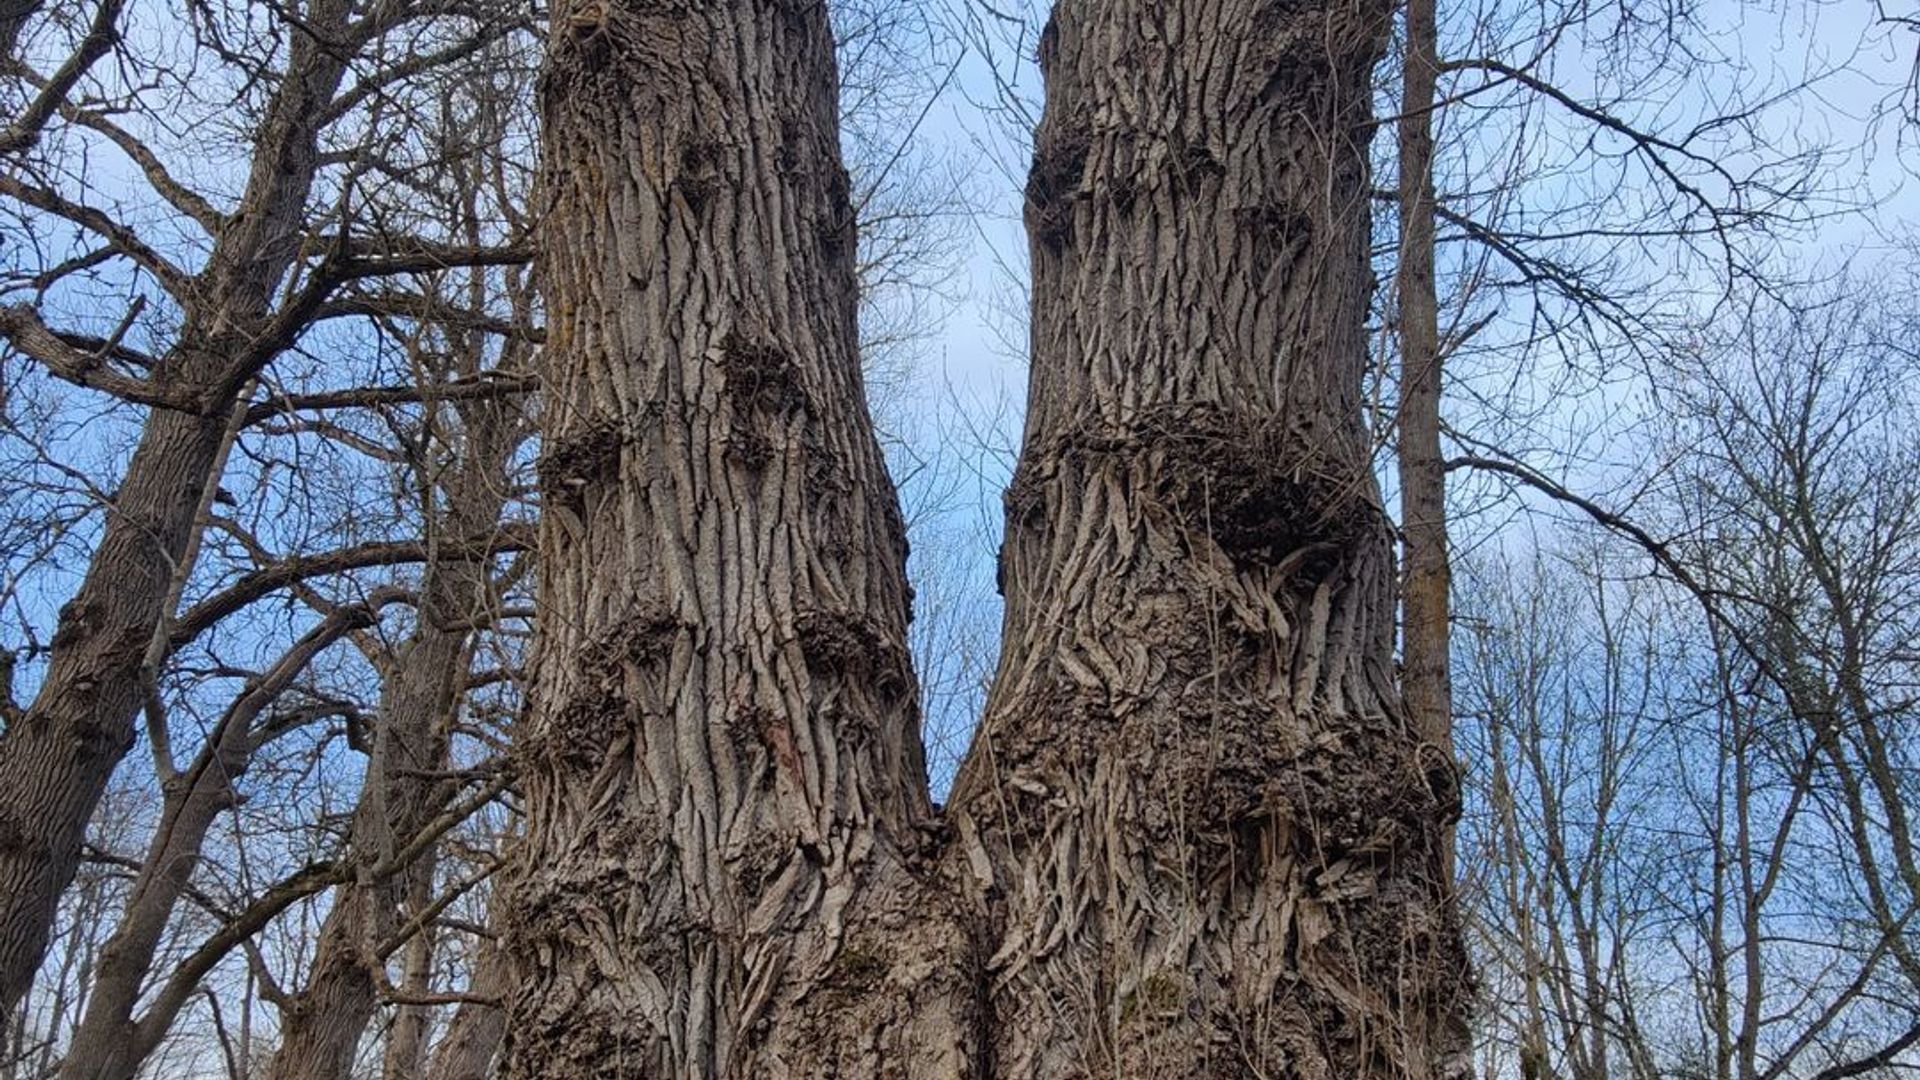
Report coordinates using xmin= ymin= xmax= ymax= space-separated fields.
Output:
xmin=952 ymin=0 xmax=1469 ymax=1078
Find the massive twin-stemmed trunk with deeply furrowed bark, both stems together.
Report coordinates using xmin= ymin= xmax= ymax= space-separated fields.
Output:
xmin=507 ymin=0 xmax=1469 ymax=1078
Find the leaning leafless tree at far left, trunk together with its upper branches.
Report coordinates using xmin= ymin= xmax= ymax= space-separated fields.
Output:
xmin=0 ymin=0 xmax=524 ymax=1037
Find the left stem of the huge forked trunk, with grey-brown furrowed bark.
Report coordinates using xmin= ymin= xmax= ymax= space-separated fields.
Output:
xmin=505 ymin=0 xmax=972 ymax=1076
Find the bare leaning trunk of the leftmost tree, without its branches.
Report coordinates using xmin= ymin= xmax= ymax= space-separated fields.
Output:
xmin=0 ymin=0 xmax=349 ymax=1015
